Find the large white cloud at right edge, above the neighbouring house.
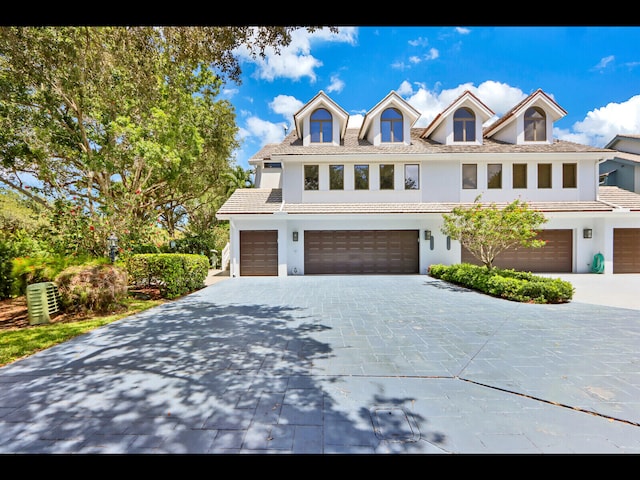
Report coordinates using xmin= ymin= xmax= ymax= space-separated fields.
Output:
xmin=558 ymin=95 xmax=640 ymax=147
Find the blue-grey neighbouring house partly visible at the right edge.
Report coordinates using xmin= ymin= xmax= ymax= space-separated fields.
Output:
xmin=600 ymin=135 xmax=640 ymax=193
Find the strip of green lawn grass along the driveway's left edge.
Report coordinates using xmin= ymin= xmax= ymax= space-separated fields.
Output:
xmin=0 ymin=298 xmax=165 ymax=367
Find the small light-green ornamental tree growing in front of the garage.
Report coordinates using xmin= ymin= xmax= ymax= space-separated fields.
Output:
xmin=440 ymin=196 xmax=547 ymax=269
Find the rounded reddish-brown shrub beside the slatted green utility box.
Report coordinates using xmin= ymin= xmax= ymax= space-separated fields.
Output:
xmin=55 ymin=263 xmax=128 ymax=313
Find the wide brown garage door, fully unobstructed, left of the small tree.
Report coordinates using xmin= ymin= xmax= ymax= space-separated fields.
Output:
xmin=304 ymin=230 xmax=420 ymax=275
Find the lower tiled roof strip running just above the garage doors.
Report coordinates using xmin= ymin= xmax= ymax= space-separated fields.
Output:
xmin=218 ymin=186 xmax=640 ymax=217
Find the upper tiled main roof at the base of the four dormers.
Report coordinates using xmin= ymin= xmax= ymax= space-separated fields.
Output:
xmin=249 ymin=128 xmax=614 ymax=163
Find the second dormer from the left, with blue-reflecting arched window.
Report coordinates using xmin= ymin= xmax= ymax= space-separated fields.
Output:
xmin=358 ymin=90 xmax=420 ymax=146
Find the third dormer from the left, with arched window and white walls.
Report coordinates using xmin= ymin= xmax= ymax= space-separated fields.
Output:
xmin=420 ymin=90 xmax=494 ymax=145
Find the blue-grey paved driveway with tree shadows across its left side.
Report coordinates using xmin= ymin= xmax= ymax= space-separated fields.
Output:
xmin=0 ymin=275 xmax=640 ymax=454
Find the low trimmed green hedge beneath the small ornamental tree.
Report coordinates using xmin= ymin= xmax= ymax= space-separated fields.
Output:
xmin=429 ymin=263 xmax=574 ymax=303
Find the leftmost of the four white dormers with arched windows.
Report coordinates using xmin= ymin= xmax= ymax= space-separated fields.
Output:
xmin=293 ymin=90 xmax=349 ymax=147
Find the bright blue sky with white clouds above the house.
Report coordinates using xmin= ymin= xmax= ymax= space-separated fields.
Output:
xmin=222 ymin=25 xmax=640 ymax=168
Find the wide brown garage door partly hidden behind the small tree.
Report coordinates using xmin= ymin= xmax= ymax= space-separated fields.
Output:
xmin=462 ymin=230 xmax=573 ymax=273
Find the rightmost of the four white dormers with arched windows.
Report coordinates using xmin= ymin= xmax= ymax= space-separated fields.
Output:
xmin=484 ymin=89 xmax=567 ymax=145
